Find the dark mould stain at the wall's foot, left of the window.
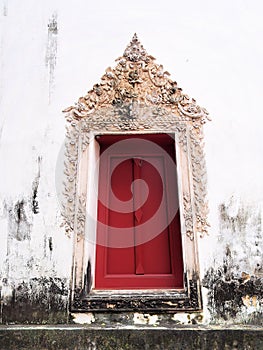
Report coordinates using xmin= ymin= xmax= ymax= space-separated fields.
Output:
xmin=1 ymin=277 xmax=68 ymax=324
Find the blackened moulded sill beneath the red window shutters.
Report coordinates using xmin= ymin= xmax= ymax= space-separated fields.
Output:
xmin=71 ymin=280 xmax=202 ymax=313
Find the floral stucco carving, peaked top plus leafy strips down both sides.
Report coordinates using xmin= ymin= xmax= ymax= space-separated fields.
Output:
xmin=63 ymin=34 xmax=209 ymax=239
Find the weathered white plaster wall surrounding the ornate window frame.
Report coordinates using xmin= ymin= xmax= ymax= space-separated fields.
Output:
xmin=0 ymin=0 xmax=263 ymax=324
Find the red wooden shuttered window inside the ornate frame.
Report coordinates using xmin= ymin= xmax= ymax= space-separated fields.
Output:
xmin=95 ymin=134 xmax=183 ymax=289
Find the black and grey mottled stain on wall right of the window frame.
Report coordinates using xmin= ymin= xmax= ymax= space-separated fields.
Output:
xmin=203 ymin=198 xmax=263 ymax=325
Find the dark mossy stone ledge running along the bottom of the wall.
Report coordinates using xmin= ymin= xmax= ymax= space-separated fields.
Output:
xmin=0 ymin=325 xmax=263 ymax=350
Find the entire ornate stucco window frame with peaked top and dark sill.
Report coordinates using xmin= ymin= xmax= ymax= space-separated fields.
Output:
xmin=63 ymin=35 xmax=208 ymax=312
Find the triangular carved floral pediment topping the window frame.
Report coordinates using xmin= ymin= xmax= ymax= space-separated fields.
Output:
xmin=64 ymin=34 xmax=208 ymax=123
